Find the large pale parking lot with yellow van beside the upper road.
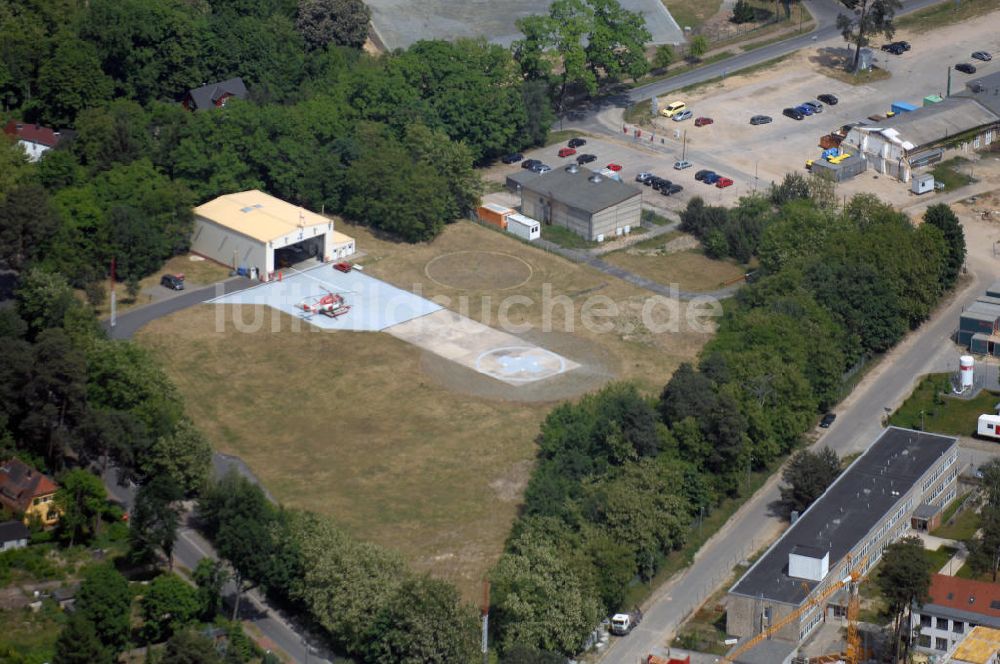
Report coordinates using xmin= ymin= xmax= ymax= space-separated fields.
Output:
xmin=654 ymin=12 xmax=1000 ymax=191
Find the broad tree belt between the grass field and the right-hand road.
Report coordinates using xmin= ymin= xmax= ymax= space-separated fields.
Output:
xmin=492 ymin=191 xmax=960 ymax=656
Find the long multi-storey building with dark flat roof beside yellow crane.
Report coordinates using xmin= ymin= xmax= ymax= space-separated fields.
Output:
xmin=726 ymin=427 xmax=958 ymax=652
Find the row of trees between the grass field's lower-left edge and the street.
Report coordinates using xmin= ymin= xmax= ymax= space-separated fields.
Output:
xmin=198 ymin=474 xmax=478 ymax=664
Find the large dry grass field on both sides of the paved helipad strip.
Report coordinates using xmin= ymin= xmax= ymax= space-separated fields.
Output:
xmin=139 ymin=222 xmax=708 ymax=599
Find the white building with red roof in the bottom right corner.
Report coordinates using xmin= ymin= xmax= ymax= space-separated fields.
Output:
xmin=912 ymin=574 xmax=1000 ymax=653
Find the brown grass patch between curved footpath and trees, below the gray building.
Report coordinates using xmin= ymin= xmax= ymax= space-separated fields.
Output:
xmin=604 ymin=244 xmax=747 ymax=291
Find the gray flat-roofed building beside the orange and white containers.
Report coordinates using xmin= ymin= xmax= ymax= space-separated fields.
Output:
xmin=508 ymin=164 xmax=642 ymax=242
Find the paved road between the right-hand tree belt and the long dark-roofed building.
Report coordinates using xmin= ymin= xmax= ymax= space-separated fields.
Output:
xmin=604 ymin=223 xmax=1000 ymax=664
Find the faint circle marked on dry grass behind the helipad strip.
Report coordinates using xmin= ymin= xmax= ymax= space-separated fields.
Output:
xmin=424 ymin=251 xmax=534 ymax=291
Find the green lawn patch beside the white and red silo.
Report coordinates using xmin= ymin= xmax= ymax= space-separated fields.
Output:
xmin=889 ymin=374 xmax=1000 ymax=436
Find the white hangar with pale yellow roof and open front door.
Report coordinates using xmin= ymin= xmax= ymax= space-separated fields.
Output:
xmin=191 ymin=190 xmax=355 ymax=280
